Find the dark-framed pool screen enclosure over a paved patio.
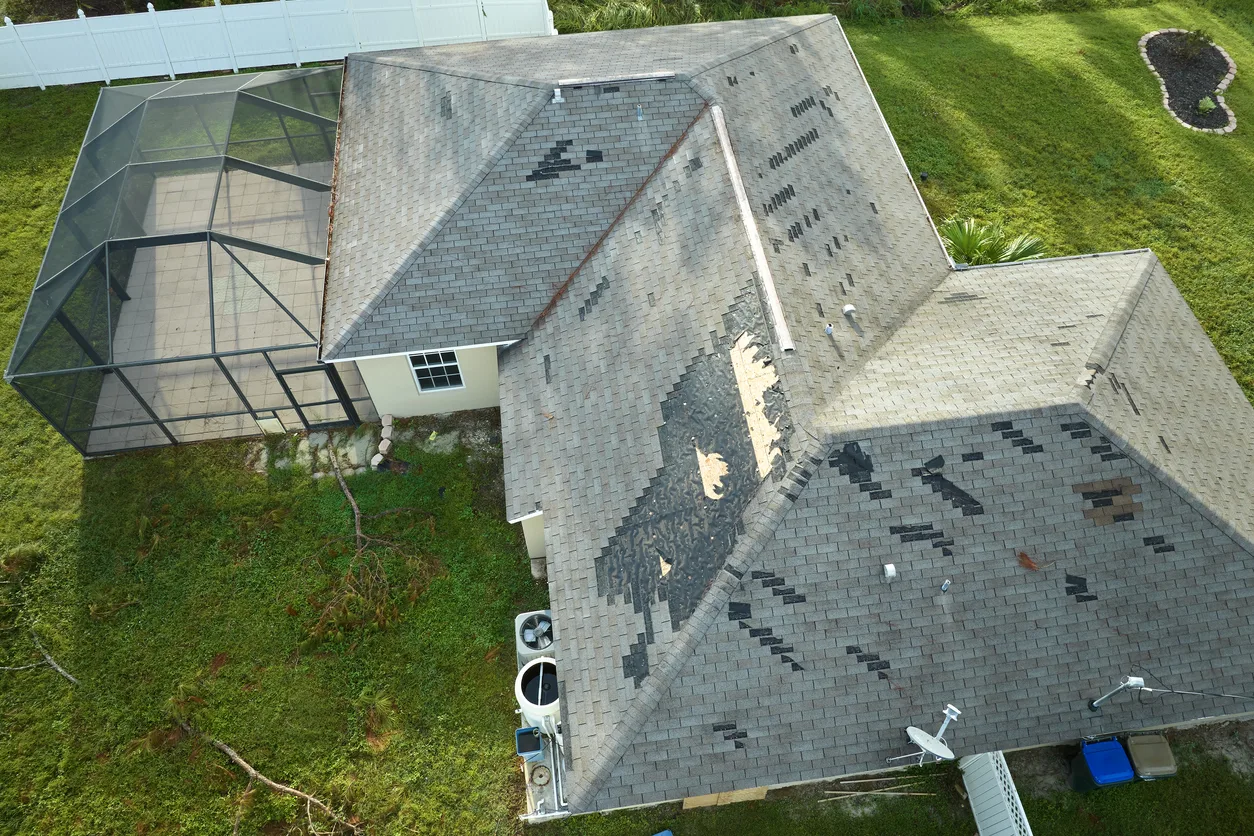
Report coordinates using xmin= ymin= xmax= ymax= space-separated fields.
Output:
xmin=5 ymin=66 xmax=374 ymax=455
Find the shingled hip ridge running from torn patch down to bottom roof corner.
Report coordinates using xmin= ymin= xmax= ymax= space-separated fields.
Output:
xmin=568 ymin=430 xmax=831 ymax=812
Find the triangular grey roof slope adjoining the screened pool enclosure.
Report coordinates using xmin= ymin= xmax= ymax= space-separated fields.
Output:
xmin=322 ymin=55 xmax=548 ymax=360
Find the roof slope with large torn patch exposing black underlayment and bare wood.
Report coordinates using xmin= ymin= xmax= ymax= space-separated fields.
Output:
xmin=500 ymin=107 xmax=791 ymax=771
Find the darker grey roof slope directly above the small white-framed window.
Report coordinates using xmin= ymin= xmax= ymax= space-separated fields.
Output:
xmin=340 ymin=80 xmax=705 ymax=356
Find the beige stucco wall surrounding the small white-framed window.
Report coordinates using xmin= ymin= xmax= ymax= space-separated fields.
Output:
xmin=357 ymin=346 xmax=500 ymax=417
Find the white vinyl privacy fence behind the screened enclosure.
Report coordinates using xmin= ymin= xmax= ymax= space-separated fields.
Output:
xmin=0 ymin=0 xmax=553 ymax=88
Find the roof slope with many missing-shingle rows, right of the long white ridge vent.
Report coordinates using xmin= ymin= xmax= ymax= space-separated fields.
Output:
xmin=693 ymin=19 xmax=949 ymax=426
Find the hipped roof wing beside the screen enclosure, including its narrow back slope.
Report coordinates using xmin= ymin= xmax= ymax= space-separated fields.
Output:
xmin=322 ymin=18 xmax=819 ymax=360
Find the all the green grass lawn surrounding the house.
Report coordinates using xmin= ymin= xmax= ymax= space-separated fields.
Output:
xmin=0 ymin=0 xmax=1254 ymax=836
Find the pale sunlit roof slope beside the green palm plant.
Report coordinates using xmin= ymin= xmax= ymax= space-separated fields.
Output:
xmin=821 ymin=251 xmax=1157 ymax=432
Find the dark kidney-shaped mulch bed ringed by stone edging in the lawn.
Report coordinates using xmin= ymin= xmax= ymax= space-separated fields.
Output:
xmin=1145 ymin=31 xmax=1231 ymax=130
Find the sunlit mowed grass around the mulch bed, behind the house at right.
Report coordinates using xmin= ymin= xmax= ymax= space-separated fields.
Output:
xmin=848 ymin=1 xmax=1254 ymax=397
